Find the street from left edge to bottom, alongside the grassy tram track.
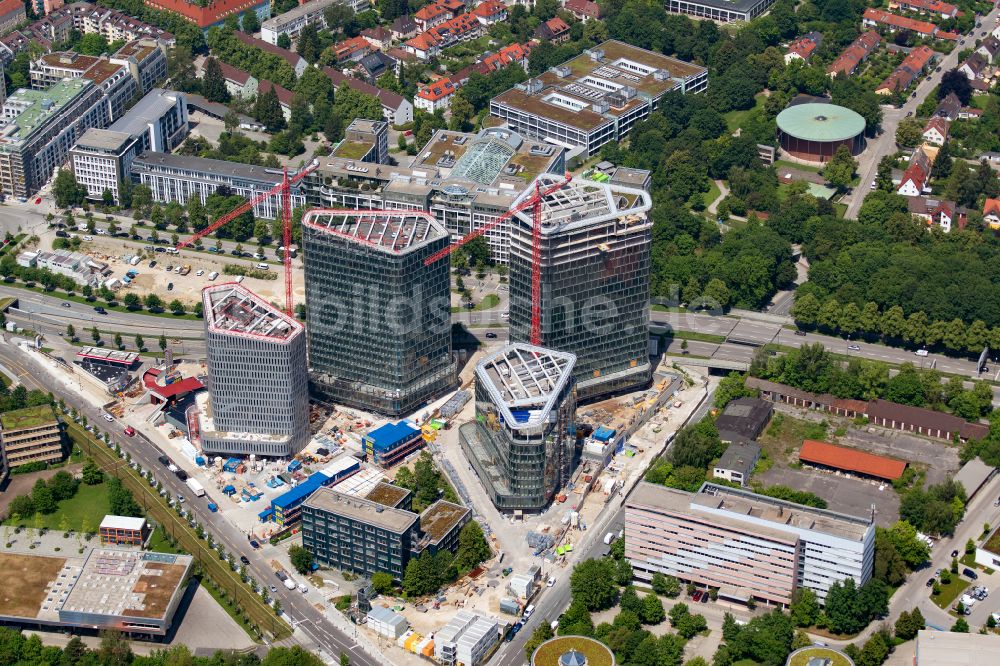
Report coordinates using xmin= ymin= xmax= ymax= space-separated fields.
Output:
xmin=0 ymin=336 xmax=384 ymax=666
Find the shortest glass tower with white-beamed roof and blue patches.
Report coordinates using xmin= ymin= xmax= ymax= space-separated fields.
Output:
xmin=460 ymin=344 xmax=576 ymax=511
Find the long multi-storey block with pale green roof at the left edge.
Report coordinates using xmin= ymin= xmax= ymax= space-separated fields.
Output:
xmin=0 ymin=79 xmax=110 ymax=197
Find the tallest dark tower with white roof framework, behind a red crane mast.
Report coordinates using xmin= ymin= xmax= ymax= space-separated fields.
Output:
xmin=510 ymin=174 xmax=652 ymax=400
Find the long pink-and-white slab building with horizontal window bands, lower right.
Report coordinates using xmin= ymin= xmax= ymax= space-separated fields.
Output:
xmin=625 ymin=482 xmax=875 ymax=605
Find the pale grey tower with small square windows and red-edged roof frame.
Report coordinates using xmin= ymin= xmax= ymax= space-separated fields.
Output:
xmin=198 ymin=283 xmax=310 ymax=457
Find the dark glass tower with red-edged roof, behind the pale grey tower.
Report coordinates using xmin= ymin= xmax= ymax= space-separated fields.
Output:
xmin=302 ymin=209 xmax=455 ymax=416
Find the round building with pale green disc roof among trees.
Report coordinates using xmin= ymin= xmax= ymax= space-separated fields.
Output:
xmin=777 ymin=102 xmax=865 ymax=162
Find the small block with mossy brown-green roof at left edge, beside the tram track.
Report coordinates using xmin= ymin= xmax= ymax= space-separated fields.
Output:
xmin=0 ymin=405 xmax=63 ymax=470
